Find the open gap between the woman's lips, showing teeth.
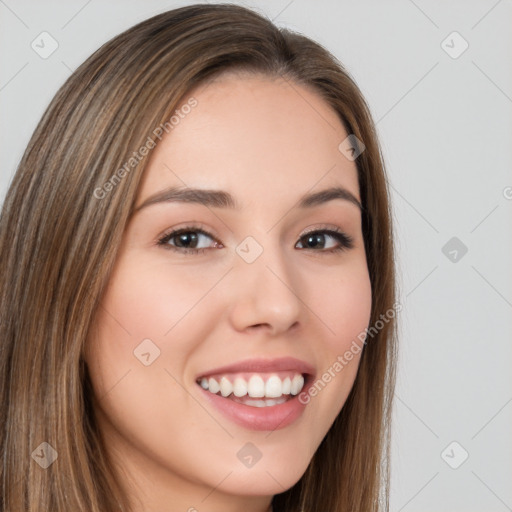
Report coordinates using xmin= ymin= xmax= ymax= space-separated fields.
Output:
xmin=196 ymin=371 xmax=307 ymax=407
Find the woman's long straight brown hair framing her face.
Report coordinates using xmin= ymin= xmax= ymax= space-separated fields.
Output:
xmin=0 ymin=4 xmax=396 ymax=512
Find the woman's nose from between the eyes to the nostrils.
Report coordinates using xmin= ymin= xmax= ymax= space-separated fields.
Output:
xmin=231 ymin=236 xmax=302 ymax=334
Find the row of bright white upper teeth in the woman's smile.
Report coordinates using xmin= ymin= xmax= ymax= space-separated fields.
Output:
xmin=198 ymin=373 xmax=304 ymax=400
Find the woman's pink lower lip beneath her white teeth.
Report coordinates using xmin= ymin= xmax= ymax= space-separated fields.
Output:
xmin=198 ymin=386 xmax=306 ymax=431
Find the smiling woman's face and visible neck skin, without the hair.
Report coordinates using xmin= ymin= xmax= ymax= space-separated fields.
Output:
xmin=86 ymin=74 xmax=371 ymax=512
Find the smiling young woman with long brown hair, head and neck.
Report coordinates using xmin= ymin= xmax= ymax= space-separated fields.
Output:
xmin=0 ymin=4 xmax=399 ymax=512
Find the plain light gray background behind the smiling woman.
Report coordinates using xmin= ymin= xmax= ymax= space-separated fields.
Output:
xmin=0 ymin=0 xmax=512 ymax=512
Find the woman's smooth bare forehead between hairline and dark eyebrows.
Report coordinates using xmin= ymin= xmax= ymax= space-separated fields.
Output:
xmin=139 ymin=73 xmax=359 ymax=208
